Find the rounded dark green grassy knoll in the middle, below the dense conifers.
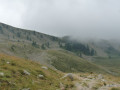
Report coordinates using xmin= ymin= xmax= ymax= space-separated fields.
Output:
xmin=47 ymin=50 xmax=104 ymax=73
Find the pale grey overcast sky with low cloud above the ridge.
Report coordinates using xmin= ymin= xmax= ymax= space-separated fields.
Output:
xmin=0 ymin=0 xmax=120 ymax=39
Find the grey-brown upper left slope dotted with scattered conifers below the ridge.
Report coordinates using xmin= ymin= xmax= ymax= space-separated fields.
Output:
xmin=0 ymin=23 xmax=60 ymax=48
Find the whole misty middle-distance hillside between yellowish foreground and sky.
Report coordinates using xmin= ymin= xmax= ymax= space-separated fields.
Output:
xmin=0 ymin=23 xmax=120 ymax=75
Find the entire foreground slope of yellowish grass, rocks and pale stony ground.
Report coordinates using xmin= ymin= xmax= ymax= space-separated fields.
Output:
xmin=0 ymin=53 xmax=120 ymax=90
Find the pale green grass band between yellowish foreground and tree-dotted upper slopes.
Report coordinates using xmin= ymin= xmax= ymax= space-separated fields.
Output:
xmin=0 ymin=41 xmax=120 ymax=74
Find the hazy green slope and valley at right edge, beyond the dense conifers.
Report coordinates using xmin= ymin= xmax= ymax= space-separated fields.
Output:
xmin=88 ymin=40 xmax=120 ymax=75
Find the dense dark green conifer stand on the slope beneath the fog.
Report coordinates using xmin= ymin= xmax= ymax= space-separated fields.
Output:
xmin=60 ymin=36 xmax=96 ymax=57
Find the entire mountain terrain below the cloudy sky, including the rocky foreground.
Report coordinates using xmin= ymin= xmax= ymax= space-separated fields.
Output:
xmin=0 ymin=23 xmax=120 ymax=90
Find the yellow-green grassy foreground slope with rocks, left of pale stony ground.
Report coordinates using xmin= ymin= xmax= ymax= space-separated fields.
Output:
xmin=0 ymin=53 xmax=72 ymax=90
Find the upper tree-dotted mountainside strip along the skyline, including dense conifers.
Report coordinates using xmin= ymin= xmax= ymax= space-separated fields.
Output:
xmin=0 ymin=23 xmax=120 ymax=56
